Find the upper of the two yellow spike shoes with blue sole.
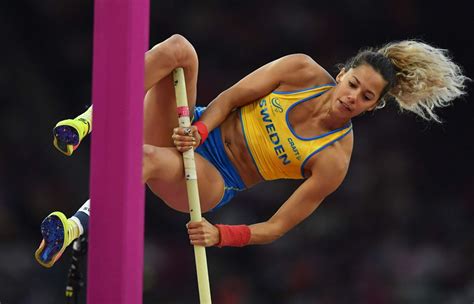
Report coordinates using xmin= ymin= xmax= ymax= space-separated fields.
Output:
xmin=53 ymin=118 xmax=91 ymax=156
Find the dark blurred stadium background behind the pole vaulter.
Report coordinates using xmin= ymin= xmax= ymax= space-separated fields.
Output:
xmin=0 ymin=0 xmax=474 ymax=304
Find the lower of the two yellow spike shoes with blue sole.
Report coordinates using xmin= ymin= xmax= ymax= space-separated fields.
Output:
xmin=35 ymin=211 xmax=79 ymax=268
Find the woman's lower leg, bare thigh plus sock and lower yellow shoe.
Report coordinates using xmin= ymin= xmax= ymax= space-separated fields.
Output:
xmin=35 ymin=141 xmax=224 ymax=268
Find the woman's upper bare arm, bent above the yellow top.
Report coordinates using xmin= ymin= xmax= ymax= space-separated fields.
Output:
xmin=196 ymin=54 xmax=330 ymax=132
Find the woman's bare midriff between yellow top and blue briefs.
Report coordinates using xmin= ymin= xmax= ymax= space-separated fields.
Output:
xmin=220 ymin=110 xmax=262 ymax=187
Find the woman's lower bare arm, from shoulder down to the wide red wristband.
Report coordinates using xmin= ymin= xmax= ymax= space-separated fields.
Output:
xmin=249 ymin=153 xmax=349 ymax=244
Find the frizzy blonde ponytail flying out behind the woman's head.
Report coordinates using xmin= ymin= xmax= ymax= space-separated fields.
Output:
xmin=378 ymin=40 xmax=470 ymax=122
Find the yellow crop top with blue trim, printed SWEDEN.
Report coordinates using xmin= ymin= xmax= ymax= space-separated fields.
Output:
xmin=240 ymin=85 xmax=352 ymax=180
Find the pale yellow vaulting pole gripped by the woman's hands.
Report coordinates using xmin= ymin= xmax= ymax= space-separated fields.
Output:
xmin=173 ymin=68 xmax=211 ymax=304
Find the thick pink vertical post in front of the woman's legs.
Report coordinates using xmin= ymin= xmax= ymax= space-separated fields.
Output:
xmin=87 ymin=0 xmax=149 ymax=304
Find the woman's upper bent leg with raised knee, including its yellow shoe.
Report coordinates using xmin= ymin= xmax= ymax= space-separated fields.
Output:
xmin=53 ymin=35 xmax=198 ymax=156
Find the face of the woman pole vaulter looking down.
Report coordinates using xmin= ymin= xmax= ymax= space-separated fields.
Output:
xmin=333 ymin=64 xmax=387 ymax=118
